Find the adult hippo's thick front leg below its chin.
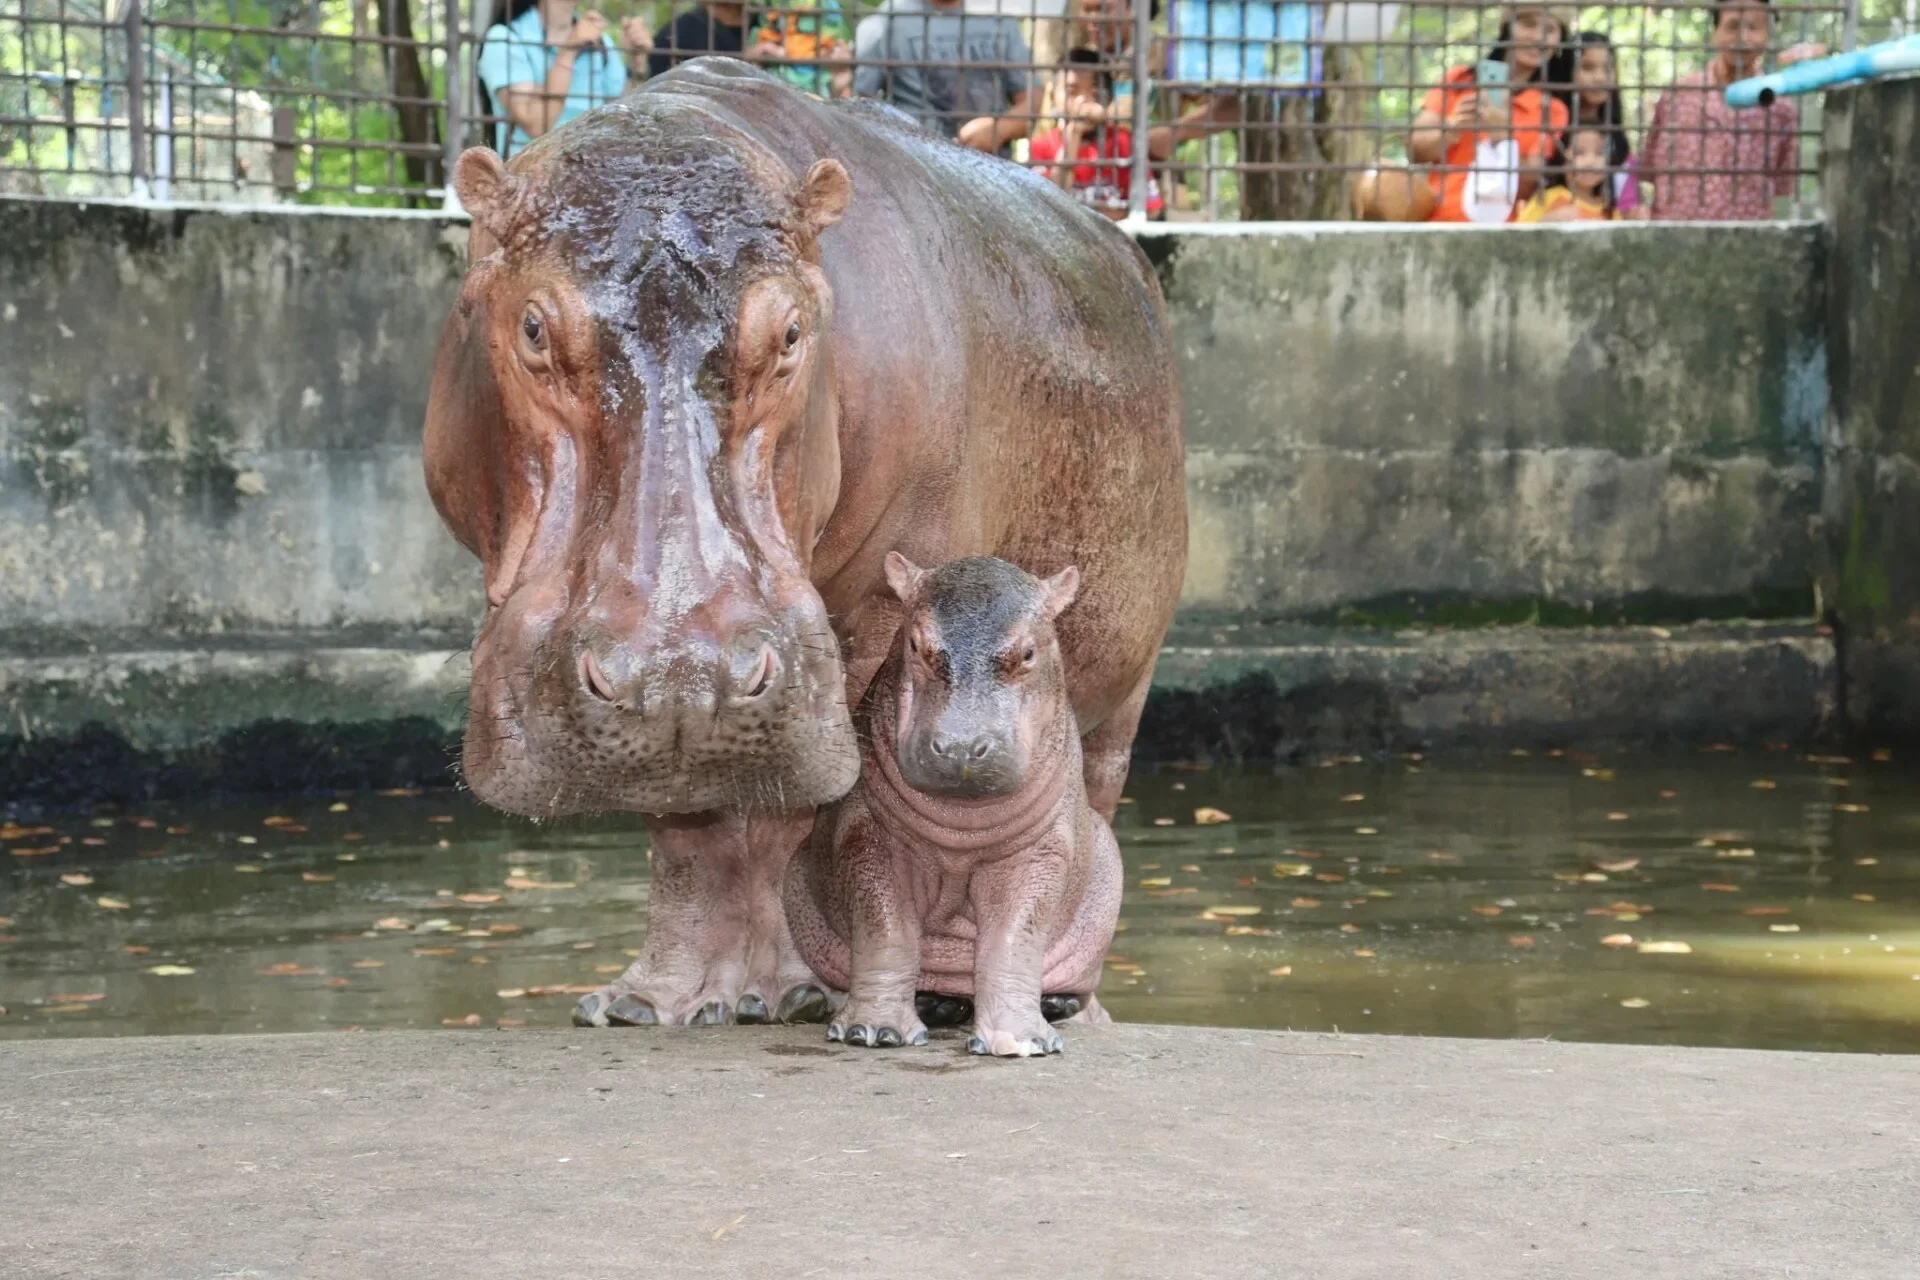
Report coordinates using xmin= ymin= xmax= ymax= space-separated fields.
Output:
xmin=574 ymin=810 xmax=828 ymax=1027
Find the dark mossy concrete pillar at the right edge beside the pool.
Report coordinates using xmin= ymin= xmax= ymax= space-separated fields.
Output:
xmin=1822 ymin=81 xmax=1920 ymax=735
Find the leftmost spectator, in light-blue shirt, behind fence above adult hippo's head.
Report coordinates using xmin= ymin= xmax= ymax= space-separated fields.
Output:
xmin=474 ymin=0 xmax=653 ymax=155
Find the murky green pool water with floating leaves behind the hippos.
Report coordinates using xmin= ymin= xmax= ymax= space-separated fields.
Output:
xmin=0 ymin=750 xmax=1920 ymax=1052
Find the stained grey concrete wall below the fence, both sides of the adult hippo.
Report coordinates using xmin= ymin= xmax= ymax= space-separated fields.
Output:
xmin=0 ymin=200 xmax=1828 ymax=652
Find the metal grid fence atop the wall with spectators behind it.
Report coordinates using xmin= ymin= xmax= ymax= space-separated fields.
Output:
xmin=0 ymin=0 xmax=1889 ymax=219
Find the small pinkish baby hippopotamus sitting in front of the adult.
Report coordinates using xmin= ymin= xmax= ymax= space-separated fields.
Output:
xmin=787 ymin=551 xmax=1121 ymax=1057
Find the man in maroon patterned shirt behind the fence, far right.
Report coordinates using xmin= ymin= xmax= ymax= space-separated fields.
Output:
xmin=1640 ymin=0 xmax=1826 ymax=223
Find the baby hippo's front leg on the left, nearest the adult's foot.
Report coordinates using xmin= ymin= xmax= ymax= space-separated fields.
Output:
xmin=828 ymin=819 xmax=927 ymax=1048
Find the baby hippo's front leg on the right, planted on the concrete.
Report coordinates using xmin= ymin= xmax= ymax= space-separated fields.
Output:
xmin=968 ymin=848 xmax=1066 ymax=1057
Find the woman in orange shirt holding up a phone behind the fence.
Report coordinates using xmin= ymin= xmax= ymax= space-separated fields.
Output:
xmin=1407 ymin=4 xmax=1567 ymax=223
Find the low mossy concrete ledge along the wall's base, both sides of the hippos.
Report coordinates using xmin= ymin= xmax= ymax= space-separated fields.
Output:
xmin=0 ymin=624 xmax=1837 ymax=804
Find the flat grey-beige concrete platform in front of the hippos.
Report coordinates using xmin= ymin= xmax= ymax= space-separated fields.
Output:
xmin=0 ymin=1027 xmax=1920 ymax=1280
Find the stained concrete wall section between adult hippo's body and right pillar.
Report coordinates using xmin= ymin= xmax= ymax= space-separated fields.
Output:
xmin=1144 ymin=225 xmax=1828 ymax=616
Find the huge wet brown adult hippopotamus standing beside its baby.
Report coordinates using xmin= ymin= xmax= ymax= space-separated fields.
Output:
xmin=424 ymin=58 xmax=1187 ymax=1025
